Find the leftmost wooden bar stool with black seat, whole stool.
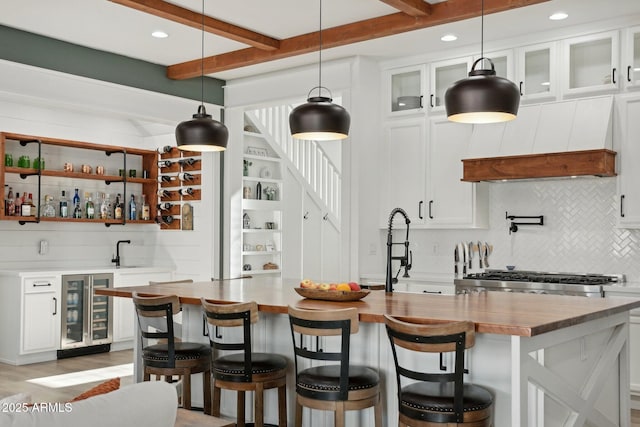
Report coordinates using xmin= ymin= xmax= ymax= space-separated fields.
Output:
xmin=133 ymin=292 xmax=211 ymax=415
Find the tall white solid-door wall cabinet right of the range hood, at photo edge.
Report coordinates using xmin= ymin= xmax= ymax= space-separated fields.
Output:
xmin=614 ymin=95 xmax=640 ymax=228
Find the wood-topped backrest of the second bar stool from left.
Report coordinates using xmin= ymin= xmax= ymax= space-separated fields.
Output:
xmin=200 ymin=298 xmax=258 ymax=382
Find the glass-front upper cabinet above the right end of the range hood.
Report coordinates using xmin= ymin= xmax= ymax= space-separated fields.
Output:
xmin=562 ymin=31 xmax=623 ymax=95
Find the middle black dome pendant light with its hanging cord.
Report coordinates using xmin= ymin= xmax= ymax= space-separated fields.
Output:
xmin=289 ymin=0 xmax=351 ymax=141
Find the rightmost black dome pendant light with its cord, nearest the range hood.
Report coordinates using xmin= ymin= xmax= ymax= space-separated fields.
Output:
xmin=444 ymin=0 xmax=520 ymax=123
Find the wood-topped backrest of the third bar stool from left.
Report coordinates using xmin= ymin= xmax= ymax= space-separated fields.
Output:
xmin=289 ymin=306 xmax=359 ymax=401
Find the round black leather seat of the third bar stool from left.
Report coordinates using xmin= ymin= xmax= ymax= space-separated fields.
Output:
xmin=297 ymin=365 xmax=380 ymax=399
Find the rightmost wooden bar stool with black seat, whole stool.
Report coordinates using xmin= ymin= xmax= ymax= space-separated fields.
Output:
xmin=384 ymin=314 xmax=493 ymax=427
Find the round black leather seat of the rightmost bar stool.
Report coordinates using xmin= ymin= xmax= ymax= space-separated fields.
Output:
xmin=400 ymin=382 xmax=493 ymax=422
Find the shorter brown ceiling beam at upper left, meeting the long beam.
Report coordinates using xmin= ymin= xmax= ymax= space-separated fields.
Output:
xmin=109 ymin=0 xmax=280 ymax=50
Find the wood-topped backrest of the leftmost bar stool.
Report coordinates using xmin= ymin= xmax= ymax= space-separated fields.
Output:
xmin=133 ymin=292 xmax=181 ymax=368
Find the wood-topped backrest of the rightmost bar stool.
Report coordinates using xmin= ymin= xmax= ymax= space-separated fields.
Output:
xmin=384 ymin=314 xmax=475 ymax=423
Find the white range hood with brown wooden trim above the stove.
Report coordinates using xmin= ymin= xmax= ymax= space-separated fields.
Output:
xmin=462 ymin=96 xmax=616 ymax=182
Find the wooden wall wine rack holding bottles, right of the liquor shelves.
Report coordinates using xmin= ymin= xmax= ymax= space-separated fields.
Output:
xmin=156 ymin=147 xmax=202 ymax=230
